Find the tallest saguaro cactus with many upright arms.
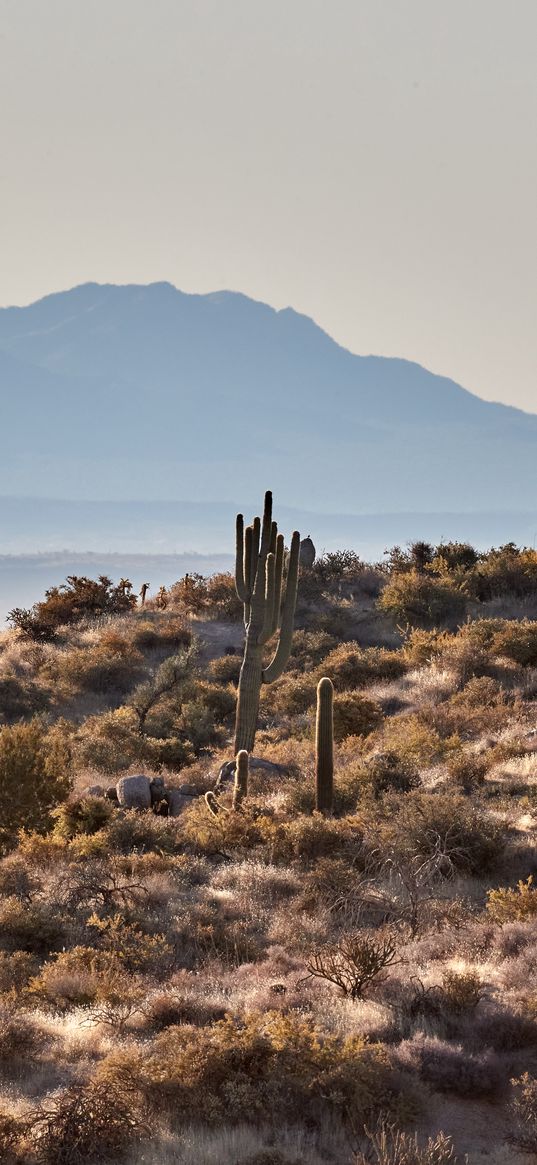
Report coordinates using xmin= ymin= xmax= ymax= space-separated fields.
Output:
xmin=234 ymin=490 xmax=301 ymax=756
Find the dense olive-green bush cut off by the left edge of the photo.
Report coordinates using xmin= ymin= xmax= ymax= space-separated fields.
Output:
xmin=0 ymin=719 xmax=71 ymax=848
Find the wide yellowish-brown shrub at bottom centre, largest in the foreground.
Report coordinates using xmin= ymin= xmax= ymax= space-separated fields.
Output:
xmin=134 ymin=1011 xmax=401 ymax=1125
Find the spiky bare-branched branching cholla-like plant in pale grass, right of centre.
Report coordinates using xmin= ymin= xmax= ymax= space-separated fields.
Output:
xmin=306 ymin=927 xmax=400 ymax=1000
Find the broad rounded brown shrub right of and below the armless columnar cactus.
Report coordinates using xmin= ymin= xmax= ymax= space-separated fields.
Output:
xmin=369 ymin=790 xmax=506 ymax=876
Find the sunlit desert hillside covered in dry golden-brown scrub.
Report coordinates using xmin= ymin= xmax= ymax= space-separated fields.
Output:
xmin=0 ymin=512 xmax=537 ymax=1165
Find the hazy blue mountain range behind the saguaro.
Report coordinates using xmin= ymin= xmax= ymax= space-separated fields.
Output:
xmin=0 ymin=283 xmax=537 ymax=512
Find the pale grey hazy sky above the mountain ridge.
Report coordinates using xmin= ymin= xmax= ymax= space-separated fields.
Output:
xmin=0 ymin=0 xmax=537 ymax=411
